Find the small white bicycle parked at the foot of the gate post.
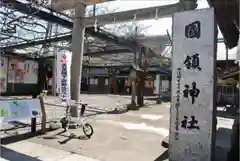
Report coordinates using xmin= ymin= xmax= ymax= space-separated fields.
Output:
xmin=60 ymin=103 xmax=94 ymax=138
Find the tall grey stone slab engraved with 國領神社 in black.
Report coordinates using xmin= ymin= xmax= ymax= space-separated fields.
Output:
xmin=169 ymin=8 xmax=216 ymax=161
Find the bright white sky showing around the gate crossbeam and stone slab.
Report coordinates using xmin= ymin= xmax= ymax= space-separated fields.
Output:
xmin=97 ymin=0 xmax=237 ymax=59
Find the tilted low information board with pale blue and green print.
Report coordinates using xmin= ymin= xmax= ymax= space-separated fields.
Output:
xmin=0 ymin=99 xmax=41 ymax=124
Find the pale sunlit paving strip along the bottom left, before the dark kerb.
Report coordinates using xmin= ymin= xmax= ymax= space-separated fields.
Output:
xmin=0 ymin=141 xmax=99 ymax=161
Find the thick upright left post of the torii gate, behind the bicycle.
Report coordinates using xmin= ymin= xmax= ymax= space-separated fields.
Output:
xmin=70 ymin=3 xmax=86 ymax=117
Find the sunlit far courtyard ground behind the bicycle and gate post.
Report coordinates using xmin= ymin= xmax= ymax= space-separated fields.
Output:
xmin=0 ymin=94 xmax=155 ymax=120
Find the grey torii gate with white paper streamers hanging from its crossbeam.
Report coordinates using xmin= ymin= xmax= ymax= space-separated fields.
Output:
xmin=52 ymin=0 xmax=197 ymax=115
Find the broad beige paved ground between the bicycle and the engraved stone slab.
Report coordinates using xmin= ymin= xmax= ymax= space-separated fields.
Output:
xmin=25 ymin=102 xmax=169 ymax=161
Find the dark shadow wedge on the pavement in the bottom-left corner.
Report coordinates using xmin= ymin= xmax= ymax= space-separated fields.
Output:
xmin=0 ymin=146 xmax=42 ymax=161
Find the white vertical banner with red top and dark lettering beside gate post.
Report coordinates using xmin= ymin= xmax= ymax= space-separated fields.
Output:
xmin=56 ymin=50 xmax=72 ymax=102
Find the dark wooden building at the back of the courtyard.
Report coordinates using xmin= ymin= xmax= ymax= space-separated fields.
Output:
xmin=84 ymin=67 xmax=171 ymax=96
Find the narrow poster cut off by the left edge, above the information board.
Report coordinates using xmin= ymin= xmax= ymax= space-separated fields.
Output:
xmin=0 ymin=56 xmax=8 ymax=93
